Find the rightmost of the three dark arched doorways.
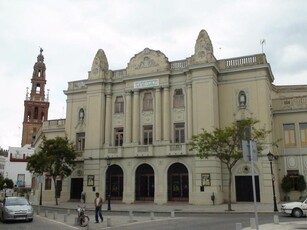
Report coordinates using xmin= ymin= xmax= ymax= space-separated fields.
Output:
xmin=167 ymin=163 xmax=189 ymax=201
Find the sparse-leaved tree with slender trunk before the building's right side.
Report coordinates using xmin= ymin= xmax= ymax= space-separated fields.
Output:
xmin=189 ymin=119 xmax=270 ymax=211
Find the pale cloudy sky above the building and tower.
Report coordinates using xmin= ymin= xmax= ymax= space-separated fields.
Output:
xmin=0 ymin=0 xmax=307 ymax=149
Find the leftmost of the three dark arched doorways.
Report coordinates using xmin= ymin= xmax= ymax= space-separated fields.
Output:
xmin=106 ymin=165 xmax=124 ymax=200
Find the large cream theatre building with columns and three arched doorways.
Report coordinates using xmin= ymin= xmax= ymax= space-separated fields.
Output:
xmin=30 ymin=30 xmax=307 ymax=204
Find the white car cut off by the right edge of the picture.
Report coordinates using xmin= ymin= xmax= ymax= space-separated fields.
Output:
xmin=280 ymin=197 xmax=307 ymax=217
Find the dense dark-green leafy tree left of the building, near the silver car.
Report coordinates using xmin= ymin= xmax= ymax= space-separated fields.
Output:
xmin=27 ymin=136 xmax=77 ymax=205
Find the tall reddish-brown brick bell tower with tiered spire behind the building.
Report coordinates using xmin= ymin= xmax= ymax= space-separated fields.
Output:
xmin=21 ymin=48 xmax=49 ymax=146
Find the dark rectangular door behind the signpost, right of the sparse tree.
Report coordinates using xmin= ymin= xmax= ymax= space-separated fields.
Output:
xmin=235 ymin=176 xmax=260 ymax=202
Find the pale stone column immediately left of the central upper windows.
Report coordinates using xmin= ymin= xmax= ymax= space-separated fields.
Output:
xmin=132 ymin=91 xmax=140 ymax=144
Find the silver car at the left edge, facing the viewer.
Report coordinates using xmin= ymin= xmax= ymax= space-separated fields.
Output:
xmin=0 ymin=197 xmax=33 ymax=222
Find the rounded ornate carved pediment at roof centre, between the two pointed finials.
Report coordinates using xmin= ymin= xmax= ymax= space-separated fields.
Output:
xmin=127 ymin=48 xmax=170 ymax=76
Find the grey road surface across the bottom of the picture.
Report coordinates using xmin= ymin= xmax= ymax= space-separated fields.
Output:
xmin=0 ymin=212 xmax=306 ymax=230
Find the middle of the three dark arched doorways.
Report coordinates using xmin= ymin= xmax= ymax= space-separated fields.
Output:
xmin=135 ymin=164 xmax=155 ymax=201
